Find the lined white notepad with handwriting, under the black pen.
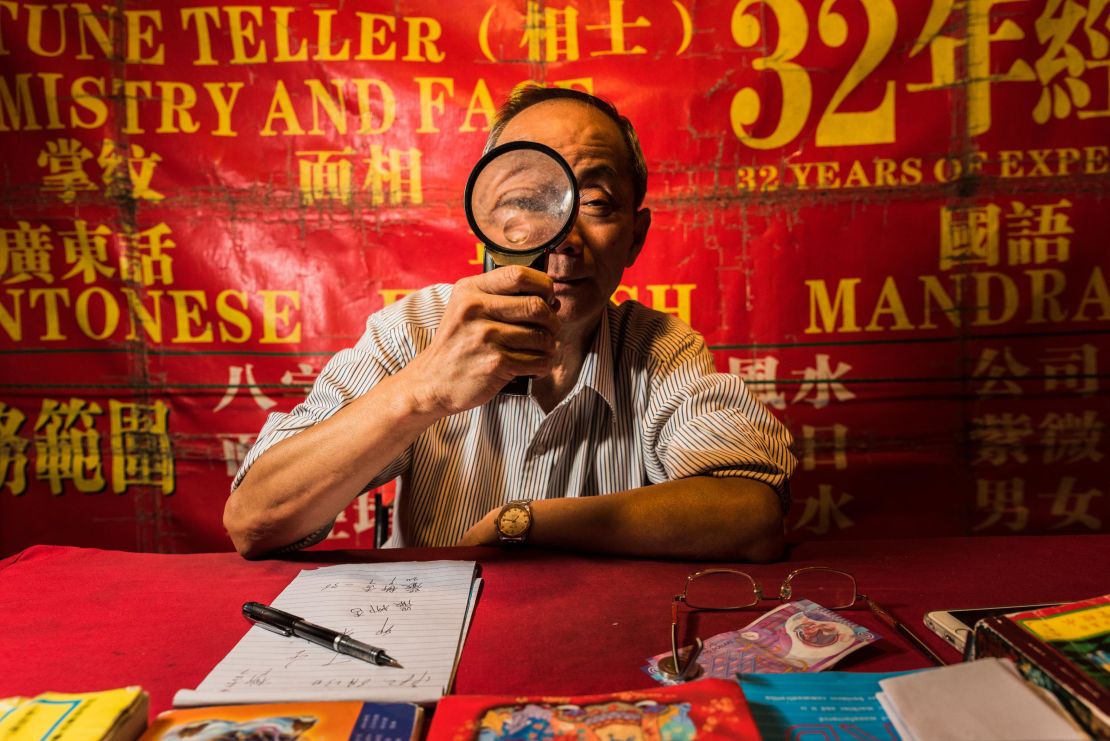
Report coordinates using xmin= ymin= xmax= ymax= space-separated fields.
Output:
xmin=173 ymin=561 xmax=481 ymax=708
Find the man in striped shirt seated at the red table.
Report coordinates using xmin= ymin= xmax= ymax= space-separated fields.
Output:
xmin=224 ymin=88 xmax=795 ymax=560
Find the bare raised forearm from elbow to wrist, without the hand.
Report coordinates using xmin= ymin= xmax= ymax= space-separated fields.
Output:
xmin=223 ymin=376 xmax=437 ymax=558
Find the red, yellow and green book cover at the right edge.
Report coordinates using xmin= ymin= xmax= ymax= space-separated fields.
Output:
xmin=1009 ymin=595 xmax=1110 ymax=691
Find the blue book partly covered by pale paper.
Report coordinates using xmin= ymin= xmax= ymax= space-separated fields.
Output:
xmin=739 ymin=671 xmax=912 ymax=741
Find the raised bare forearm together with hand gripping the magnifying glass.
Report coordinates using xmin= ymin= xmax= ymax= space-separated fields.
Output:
xmin=224 ymin=267 xmax=558 ymax=557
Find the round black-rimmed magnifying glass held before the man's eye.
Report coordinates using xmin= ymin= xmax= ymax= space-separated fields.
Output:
xmin=463 ymin=141 xmax=578 ymax=395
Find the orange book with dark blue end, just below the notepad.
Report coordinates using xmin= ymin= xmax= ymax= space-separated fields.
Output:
xmin=142 ymin=701 xmax=424 ymax=741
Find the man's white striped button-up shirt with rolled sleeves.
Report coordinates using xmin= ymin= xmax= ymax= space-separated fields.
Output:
xmin=232 ymin=285 xmax=796 ymax=547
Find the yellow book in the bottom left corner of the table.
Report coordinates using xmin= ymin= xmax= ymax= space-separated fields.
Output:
xmin=0 ymin=687 xmax=150 ymax=741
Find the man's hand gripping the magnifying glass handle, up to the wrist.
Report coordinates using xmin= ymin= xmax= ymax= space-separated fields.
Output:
xmin=396 ymin=266 xmax=558 ymax=416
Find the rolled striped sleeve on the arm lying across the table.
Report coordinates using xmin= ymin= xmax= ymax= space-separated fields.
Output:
xmin=644 ymin=331 xmax=797 ymax=512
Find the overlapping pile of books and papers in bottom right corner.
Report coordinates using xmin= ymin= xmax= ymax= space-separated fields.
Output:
xmin=739 ymin=595 xmax=1110 ymax=741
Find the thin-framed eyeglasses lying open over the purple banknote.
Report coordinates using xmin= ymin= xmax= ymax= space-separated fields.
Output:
xmin=664 ymin=566 xmax=947 ymax=681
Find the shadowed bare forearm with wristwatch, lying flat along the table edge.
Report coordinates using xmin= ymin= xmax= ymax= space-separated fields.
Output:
xmin=467 ymin=476 xmax=783 ymax=561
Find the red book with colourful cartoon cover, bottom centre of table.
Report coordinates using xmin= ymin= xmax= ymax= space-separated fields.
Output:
xmin=427 ymin=679 xmax=759 ymax=741
